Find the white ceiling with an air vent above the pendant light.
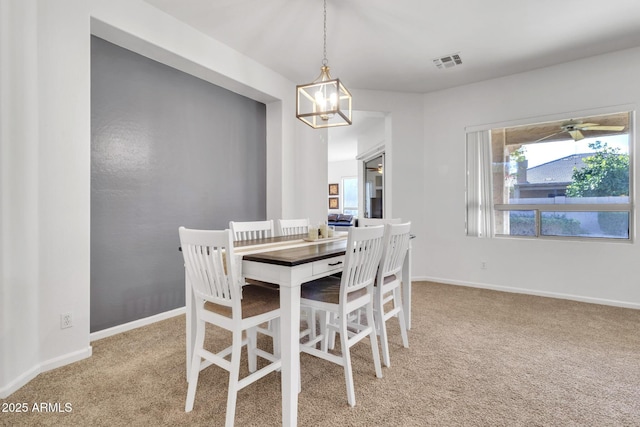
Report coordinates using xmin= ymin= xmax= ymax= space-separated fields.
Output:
xmin=145 ymin=0 xmax=640 ymax=93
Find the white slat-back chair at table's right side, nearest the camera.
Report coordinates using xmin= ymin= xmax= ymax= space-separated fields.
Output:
xmin=300 ymin=226 xmax=384 ymax=406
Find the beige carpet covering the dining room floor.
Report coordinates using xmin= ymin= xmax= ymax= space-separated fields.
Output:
xmin=0 ymin=282 xmax=640 ymax=426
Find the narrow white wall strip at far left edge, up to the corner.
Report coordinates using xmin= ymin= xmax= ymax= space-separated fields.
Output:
xmin=0 ymin=0 xmax=40 ymax=397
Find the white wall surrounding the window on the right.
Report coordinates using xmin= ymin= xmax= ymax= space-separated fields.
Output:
xmin=420 ymin=48 xmax=640 ymax=308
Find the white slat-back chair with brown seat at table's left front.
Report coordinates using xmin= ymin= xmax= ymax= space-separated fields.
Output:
xmin=179 ymin=227 xmax=281 ymax=427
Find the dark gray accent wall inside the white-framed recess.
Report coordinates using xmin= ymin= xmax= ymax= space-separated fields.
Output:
xmin=91 ymin=37 xmax=266 ymax=332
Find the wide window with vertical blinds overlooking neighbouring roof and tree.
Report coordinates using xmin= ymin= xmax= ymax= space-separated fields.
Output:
xmin=467 ymin=112 xmax=633 ymax=241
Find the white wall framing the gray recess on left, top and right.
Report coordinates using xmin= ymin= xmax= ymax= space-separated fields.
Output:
xmin=0 ymin=0 xmax=327 ymax=398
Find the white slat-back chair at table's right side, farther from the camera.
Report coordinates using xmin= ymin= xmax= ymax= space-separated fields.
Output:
xmin=373 ymin=222 xmax=411 ymax=366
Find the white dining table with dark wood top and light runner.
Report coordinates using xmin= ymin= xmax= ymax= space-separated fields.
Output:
xmin=185 ymin=232 xmax=411 ymax=426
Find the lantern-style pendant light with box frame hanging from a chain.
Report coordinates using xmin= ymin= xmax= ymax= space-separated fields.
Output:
xmin=296 ymin=0 xmax=351 ymax=129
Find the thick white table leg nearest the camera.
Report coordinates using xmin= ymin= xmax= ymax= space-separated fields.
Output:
xmin=280 ymin=286 xmax=300 ymax=426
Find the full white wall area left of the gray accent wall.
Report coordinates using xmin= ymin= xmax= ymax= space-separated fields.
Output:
xmin=0 ymin=0 xmax=91 ymax=396
